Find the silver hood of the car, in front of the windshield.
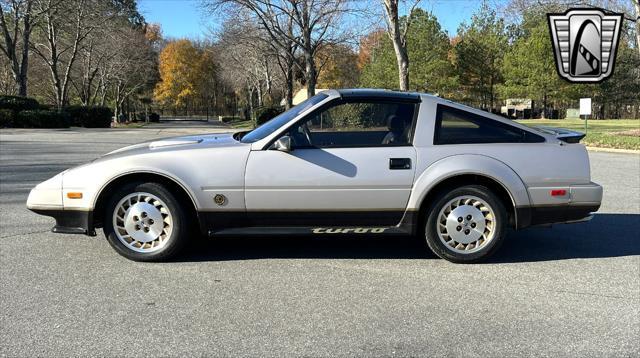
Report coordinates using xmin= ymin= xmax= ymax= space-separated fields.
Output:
xmin=101 ymin=133 xmax=246 ymax=158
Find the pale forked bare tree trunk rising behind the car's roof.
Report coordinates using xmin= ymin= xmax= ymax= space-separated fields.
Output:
xmin=382 ymin=0 xmax=420 ymax=91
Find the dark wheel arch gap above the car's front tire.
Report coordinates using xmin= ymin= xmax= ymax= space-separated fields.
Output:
xmin=93 ymin=171 xmax=198 ymax=231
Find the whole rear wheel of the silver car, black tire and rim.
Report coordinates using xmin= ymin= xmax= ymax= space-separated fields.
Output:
xmin=425 ymin=185 xmax=507 ymax=263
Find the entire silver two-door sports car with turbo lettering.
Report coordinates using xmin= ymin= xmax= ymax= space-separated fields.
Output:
xmin=27 ymin=89 xmax=602 ymax=263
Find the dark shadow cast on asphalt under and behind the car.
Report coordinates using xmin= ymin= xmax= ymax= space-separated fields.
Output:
xmin=175 ymin=214 xmax=640 ymax=263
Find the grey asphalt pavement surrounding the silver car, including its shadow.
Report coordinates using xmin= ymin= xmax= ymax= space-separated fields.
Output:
xmin=0 ymin=124 xmax=640 ymax=357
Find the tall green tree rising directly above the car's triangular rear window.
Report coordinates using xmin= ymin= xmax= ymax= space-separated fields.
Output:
xmin=454 ymin=2 xmax=509 ymax=110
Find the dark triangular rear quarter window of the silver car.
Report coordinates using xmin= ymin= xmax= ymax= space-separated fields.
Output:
xmin=433 ymin=105 xmax=544 ymax=144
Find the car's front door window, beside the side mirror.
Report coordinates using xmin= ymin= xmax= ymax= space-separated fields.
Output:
xmin=289 ymin=101 xmax=416 ymax=148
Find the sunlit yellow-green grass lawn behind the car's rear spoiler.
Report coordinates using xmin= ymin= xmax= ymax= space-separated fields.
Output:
xmin=518 ymin=119 xmax=640 ymax=150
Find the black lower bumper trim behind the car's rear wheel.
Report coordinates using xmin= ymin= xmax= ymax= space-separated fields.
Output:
xmin=516 ymin=204 xmax=600 ymax=229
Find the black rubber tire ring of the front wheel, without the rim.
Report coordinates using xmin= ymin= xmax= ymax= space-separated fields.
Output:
xmin=103 ymin=183 xmax=187 ymax=261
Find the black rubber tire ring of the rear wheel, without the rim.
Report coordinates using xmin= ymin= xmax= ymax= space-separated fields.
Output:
xmin=425 ymin=185 xmax=507 ymax=263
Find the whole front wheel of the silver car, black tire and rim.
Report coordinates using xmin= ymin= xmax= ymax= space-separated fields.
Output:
xmin=104 ymin=183 xmax=190 ymax=261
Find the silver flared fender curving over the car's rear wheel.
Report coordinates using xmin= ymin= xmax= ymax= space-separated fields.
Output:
xmin=408 ymin=154 xmax=530 ymax=210
